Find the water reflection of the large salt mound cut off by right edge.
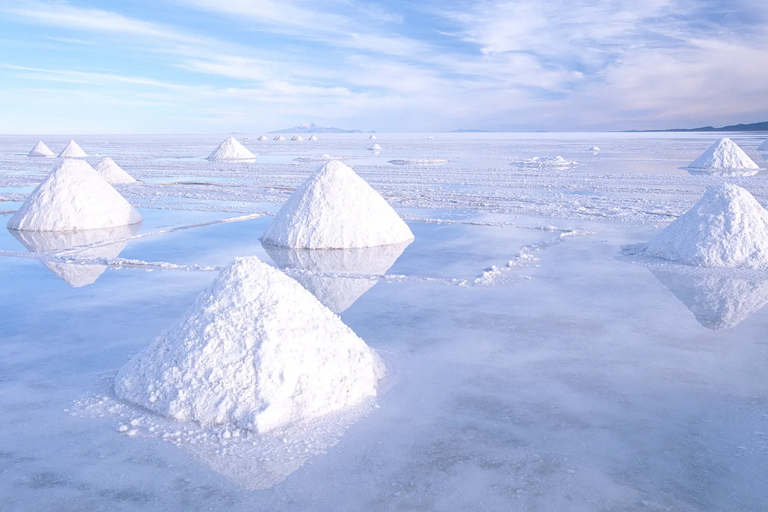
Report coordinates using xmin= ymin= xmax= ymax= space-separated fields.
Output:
xmin=651 ymin=268 xmax=768 ymax=330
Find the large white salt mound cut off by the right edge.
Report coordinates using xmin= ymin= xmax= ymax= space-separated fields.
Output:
xmin=640 ymin=184 xmax=768 ymax=268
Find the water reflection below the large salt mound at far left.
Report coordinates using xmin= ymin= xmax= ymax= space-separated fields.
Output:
xmin=11 ymin=224 xmax=141 ymax=288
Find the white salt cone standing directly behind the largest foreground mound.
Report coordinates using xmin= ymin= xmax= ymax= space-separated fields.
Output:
xmin=263 ymin=160 xmax=413 ymax=249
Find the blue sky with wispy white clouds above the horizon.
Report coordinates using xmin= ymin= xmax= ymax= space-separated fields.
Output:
xmin=0 ymin=0 xmax=768 ymax=134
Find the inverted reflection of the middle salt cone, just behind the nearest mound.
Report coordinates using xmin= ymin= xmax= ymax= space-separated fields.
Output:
xmin=264 ymin=242 xmax=410 ymax=313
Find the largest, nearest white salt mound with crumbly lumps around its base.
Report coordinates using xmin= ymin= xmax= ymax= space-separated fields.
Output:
xmin=115 ymin=257 xmax=384 ymax=433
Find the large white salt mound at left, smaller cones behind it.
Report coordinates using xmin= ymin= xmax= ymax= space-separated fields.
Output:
xmin=8 ymin=160 xmax=141 ymax=231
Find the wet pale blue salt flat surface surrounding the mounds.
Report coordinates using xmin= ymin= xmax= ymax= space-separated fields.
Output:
xmin=0 ymin=134 xmax=768 ymax=511
